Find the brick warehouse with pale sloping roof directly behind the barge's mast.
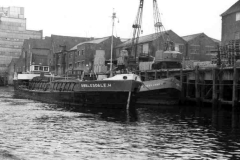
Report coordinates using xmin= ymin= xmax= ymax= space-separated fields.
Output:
xmin=55 ymin=36 xmax=121 ymax=75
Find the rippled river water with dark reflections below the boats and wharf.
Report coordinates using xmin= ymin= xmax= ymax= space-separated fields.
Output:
xmin=0 ymin=88 xmax=240 ymax=160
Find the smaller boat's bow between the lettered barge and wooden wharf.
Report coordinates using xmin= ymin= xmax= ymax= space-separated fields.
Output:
xmin=137 ymin=77 xmax=181 ymax=105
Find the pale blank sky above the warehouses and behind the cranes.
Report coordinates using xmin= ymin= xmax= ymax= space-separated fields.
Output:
xmin=0 ymin=0 xmax=238 ymax=40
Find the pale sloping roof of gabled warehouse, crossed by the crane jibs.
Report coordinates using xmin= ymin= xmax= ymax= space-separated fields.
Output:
xmin=117 ymin=30 xmax=171 ymax=48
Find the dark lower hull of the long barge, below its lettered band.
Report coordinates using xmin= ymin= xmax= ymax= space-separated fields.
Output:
xmin=15 ymin=89 xmax=136 ymax=107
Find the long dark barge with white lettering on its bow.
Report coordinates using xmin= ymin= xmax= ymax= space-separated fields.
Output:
xmin=14 ymin=74 xmax=142 ymax=107
